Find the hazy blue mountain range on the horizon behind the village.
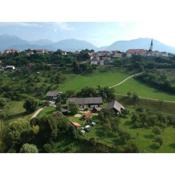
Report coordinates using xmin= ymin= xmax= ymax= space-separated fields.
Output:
xmin=0 ymin=35 xmax=175 ymax=53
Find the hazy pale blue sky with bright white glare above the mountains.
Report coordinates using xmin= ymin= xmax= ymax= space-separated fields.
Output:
xmin=0 ymin=22 xmax=175 ymax=46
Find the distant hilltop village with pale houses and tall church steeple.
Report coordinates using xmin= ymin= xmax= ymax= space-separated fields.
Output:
xmin=0 ymin=40 xmax=174 ymax=71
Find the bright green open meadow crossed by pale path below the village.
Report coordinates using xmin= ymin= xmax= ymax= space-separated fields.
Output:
xmin=59 ymin=71 xmax=175 ymax=101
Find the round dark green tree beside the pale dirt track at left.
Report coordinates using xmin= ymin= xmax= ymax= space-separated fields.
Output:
xmin=23 ymin=98 xmax=37 ymax=113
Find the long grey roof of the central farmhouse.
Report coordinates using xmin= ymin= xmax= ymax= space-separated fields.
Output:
xmin=68 ymin=97 xmax=103 ymax=105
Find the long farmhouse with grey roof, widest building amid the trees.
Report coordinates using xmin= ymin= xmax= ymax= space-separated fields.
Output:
xmin=68 ymin=97 xmax=103 ymax=109
